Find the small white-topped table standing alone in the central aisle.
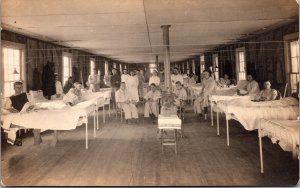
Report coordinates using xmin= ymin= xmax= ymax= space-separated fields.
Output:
xmin=158 ymin=115 xmax=181 ymax=154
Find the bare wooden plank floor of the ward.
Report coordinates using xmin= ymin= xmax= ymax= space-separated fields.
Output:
xmin=1 ymin=105 xmax=299 ymax=186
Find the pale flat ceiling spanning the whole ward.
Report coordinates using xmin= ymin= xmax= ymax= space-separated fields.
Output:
xmin=1 ymin=0 xmax=298 ymax=63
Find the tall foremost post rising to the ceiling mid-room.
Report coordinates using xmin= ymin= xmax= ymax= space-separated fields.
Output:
xmin=161 ymin=25 xmax=171 ymax=89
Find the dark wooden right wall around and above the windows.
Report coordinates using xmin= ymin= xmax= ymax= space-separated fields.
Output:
xmin=205 ymin=21 xmax=299 ymax=90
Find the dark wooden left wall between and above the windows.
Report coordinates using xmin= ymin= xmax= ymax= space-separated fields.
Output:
xmin=1 ymin=30 xmax=126 ymax=90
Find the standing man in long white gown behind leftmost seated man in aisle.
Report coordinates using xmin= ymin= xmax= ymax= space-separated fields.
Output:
xmin=125 ymin=71 xmax=139 ymax=102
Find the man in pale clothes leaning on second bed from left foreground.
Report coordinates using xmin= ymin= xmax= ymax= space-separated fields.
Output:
xmin=63 ymin=82 xmax=82 ymax=106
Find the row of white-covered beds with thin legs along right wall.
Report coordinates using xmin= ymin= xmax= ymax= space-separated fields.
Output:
xmin=189 ymin=82 xmax=299 ymax=173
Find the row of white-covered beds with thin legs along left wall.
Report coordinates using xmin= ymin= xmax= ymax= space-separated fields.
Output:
xmin=1 ymin=88 xmax=111 ymax=149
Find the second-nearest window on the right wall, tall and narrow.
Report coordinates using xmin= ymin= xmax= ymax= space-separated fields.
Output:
xmin=235 ymin=47 xmax=246 ymax=81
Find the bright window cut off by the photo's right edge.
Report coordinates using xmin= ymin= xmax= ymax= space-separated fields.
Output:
xmin=290 ymin=40 xmax=299 ymax=93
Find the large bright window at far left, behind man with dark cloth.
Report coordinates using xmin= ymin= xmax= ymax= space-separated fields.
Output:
xmin=2 ymin=42 xmax=26 ymax=97
